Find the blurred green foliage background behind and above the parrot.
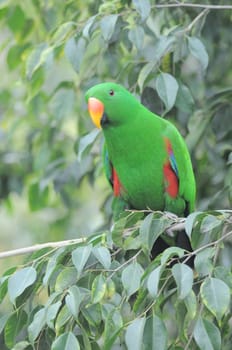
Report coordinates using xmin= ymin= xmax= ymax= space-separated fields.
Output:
xmin=0 ymin=0 xmax=232 ymax=348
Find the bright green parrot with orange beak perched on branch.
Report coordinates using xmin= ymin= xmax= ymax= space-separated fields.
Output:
xmin=86 ymin=82 xmax=196 ymax=216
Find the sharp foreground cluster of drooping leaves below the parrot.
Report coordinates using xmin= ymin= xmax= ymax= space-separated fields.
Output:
xmin=0 ymin=211 xmax=232 ymax=350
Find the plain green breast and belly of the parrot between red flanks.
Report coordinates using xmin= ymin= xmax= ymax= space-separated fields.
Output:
xmin=104 ymin=117 xmax=165 ymax=210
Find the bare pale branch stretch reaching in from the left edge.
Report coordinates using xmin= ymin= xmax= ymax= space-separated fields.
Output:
xmin=0 ymin=238 xmax=86 ymax=259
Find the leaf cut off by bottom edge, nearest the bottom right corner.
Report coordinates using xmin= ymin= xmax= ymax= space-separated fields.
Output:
xmin=193 ymin=317 xmax=221 ymax=350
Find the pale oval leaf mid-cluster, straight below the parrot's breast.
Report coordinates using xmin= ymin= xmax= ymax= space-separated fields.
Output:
xmin=122 ymin=261 xmax=144 ymax=296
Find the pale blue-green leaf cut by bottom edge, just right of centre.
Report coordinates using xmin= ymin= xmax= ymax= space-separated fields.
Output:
xmin=125 ymin=317 xmax=146 ymax=350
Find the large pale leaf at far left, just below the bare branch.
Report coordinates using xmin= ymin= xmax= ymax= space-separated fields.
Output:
xmin=8 ymin=267 xmax=37 ymax=303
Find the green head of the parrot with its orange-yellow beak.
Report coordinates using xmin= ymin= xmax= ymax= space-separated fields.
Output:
xmin=85 ymin=83 xmax=140 ymax=129
